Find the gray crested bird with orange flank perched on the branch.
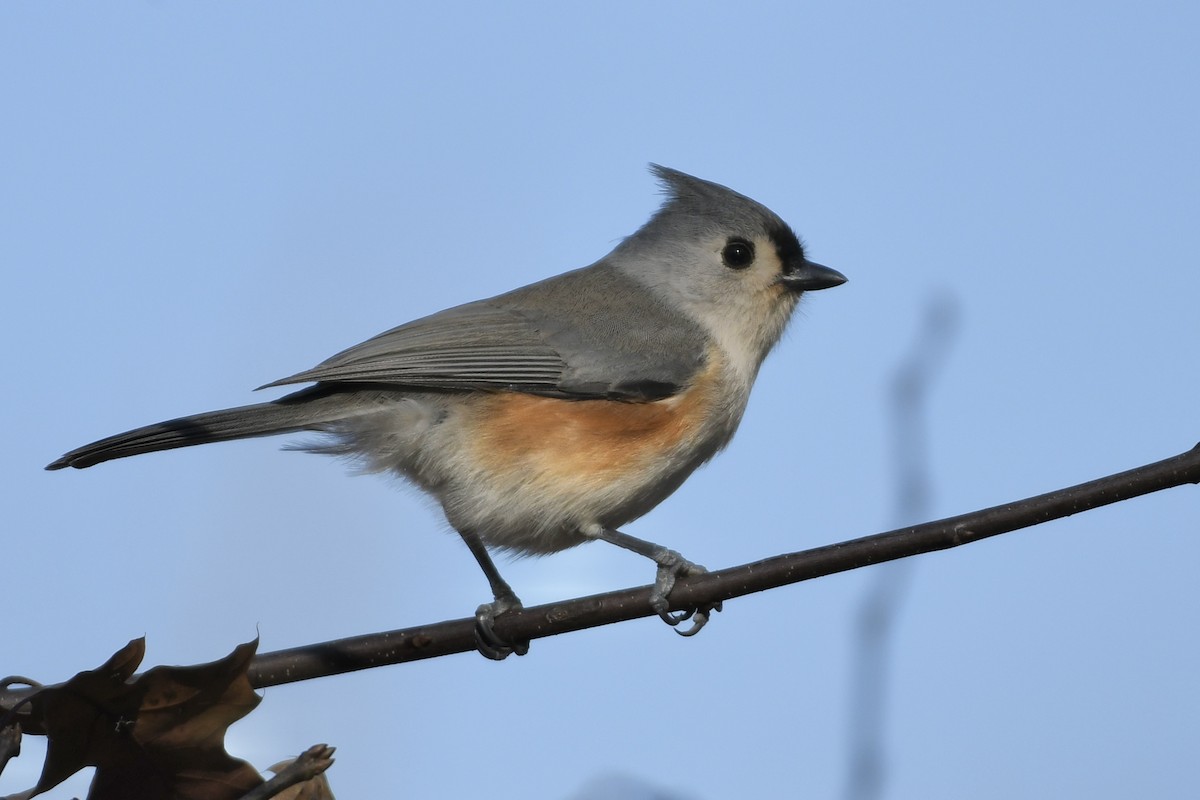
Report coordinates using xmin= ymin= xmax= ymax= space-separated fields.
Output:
xmin=47 ymin=166 xmax=846 ymax=658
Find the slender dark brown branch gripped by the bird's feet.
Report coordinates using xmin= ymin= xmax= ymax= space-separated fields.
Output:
xmin=246 ymin=445 xmax=1200 ymax=690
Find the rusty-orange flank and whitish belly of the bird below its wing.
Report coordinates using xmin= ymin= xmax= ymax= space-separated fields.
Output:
xmin=438 ymin=359 xmax=745 ymax=553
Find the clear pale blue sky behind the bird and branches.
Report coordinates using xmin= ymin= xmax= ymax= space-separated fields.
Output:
xmin=0 ymin=2 xmax=1200 ymax=800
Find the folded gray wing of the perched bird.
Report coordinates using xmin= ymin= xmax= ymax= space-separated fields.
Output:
xmin=266 ymin=261 xmax=707 ymax=401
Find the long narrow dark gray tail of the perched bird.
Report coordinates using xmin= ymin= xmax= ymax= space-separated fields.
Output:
xmin=46 ymin=387 xmax=353 ymax=470
